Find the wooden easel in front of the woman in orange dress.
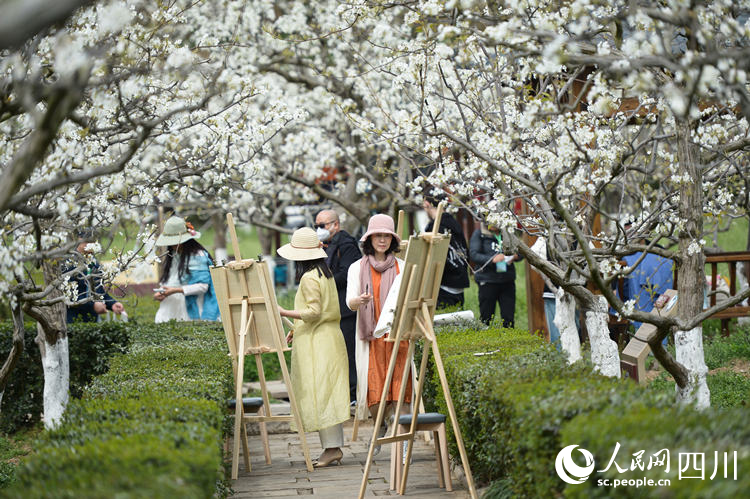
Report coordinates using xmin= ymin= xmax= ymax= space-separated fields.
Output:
xmin=359 ymin=204 xmax=477 ymax=499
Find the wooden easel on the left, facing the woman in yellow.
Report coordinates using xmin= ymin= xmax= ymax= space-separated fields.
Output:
xmin=211 ymin=213 xmax=313 ymax=480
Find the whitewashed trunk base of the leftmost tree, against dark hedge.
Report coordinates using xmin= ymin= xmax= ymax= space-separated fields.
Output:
xmin=41 ymin=337 xmax=70 ymax=429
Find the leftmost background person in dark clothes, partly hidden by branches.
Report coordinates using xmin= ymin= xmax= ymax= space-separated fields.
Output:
xmin=63 ymin=231 xmax=125 ymax=324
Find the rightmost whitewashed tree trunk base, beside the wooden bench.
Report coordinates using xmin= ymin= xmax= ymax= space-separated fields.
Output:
xmin=674 ymin=326 xmax=711 ymax=409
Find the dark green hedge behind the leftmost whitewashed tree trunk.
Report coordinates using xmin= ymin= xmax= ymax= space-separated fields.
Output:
xmin=0 ymin=321 xmax=130 ymax=433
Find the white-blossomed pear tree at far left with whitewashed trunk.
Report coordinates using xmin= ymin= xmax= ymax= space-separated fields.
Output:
xmin=0 ymin=0 xmax=304 ymax=427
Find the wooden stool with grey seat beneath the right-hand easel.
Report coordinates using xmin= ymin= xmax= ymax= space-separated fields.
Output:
xmin=394 ymin=412 xmax=453 ymax=491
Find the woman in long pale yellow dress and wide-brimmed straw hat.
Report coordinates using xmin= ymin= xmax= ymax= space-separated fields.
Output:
xmin=277 ymin=227 xmax=349 ymax=468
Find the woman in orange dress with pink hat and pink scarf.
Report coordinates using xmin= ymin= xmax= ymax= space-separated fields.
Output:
xmin=346 ymin=215 xmax=412 ymax=446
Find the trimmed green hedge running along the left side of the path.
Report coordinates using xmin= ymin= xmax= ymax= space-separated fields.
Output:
xmin=2 ymin=323 xmax=232 ymax=498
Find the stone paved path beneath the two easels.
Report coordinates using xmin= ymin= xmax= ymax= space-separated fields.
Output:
xmin=232 ymin=421 xmax=469 ymax=499
